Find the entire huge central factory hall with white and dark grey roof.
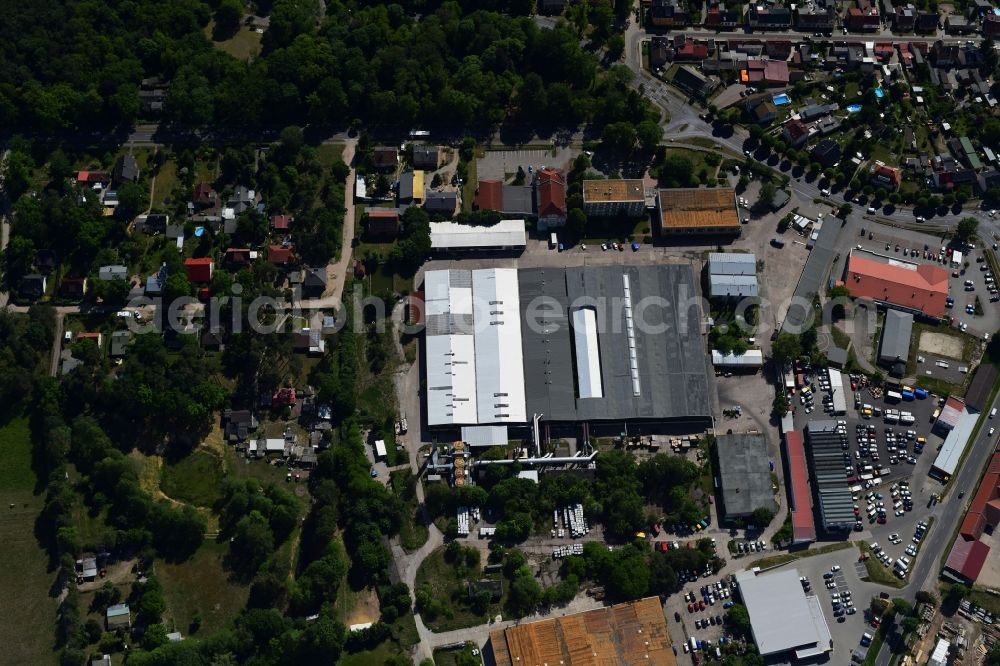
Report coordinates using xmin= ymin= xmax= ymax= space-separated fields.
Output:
xmin=422 ymin=265 xmax=712 ymax=436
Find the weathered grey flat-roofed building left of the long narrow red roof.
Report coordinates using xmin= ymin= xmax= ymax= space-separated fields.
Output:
xmin=716 ymin=433 xmax=776 ymax=517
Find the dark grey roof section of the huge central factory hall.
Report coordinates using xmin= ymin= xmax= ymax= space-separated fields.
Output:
xmin=518 ymin=264 xmax=711 ymax=421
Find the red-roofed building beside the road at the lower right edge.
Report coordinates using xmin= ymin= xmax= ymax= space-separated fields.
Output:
xmin=945 ymin=453 xmax=1000 ymax=583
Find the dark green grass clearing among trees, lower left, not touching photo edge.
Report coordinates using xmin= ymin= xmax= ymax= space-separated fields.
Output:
xmin=156 ymin=541 xmax=249 ymax=636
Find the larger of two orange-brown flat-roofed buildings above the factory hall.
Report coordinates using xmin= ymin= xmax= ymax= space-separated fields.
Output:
xmin=656 ymin=187 xmax=741 ymax=236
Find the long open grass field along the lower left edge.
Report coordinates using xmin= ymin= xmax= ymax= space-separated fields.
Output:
xmin=0 ymin=418 xmax=57 ymax=664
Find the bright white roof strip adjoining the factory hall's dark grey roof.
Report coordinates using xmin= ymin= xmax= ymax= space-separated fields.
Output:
xmin=472 ymin=268 xmax=527 ymax=423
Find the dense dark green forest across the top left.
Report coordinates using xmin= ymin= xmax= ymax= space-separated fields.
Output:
xmin=0 ymin=0 xmax=651 ymax=135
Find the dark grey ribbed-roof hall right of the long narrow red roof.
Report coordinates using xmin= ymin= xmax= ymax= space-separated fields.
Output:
xmin=806 ymin=419 xmax=857 ymax=532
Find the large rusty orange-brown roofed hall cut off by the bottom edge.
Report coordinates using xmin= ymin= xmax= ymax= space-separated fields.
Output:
xmin=484 ymin=597 xmax=677 ymax=666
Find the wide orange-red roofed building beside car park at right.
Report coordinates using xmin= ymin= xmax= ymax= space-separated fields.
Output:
xmin=844 ymin=252 xmax=948 ymax=319
